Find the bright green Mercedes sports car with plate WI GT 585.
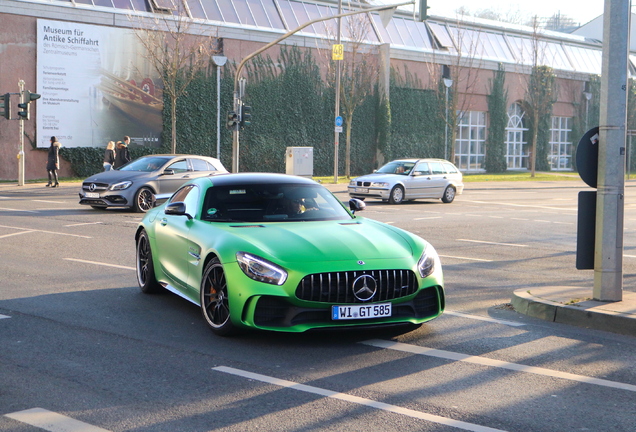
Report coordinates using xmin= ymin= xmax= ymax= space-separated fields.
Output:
xmin=135 ymin=173 xmax=444 ymax=336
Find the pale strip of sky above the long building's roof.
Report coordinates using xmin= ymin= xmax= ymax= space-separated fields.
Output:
xmin=428 ymin=0 xmax=605 ymax=24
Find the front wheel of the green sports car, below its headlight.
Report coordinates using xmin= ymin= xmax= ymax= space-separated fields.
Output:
xmin=201 ymin=258 xmax=236 ymax=336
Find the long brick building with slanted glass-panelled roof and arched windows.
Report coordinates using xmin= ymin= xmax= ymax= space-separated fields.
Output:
xmin=0 ymin=0 xmax=620 ymax=180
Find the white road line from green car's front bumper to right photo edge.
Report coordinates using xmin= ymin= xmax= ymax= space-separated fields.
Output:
xmin=360 ymin=339 xmax=636 ymax=392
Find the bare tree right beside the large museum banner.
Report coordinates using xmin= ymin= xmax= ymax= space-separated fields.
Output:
xmin=129 ymin=0 xmax=219 ymax=154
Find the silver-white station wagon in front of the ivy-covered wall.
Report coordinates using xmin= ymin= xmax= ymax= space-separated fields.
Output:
xmin=348 ymin=159 xmax=464 ymax=204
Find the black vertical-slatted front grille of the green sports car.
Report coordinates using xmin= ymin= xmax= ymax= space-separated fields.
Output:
xmin=296 ymin=270 xmax=417 ymax=304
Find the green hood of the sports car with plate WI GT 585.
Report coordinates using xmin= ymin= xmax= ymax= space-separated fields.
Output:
xmin=229 ymin=218 xmax=423 ymax=264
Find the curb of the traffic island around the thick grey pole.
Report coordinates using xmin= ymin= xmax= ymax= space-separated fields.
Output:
xmin=512 ymin=289 xmax=636 ymax=336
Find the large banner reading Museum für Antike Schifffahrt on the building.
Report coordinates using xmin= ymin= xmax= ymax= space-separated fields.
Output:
xmin=32 ymin=19 xmax=163 ymax=147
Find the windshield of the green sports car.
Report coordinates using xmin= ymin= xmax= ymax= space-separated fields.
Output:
xmin=202 ymin=184 xmax=351 ymax=222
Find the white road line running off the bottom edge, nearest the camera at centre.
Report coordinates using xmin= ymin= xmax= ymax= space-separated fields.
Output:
xmin=212 ymin=366 xmax=501 ymax=432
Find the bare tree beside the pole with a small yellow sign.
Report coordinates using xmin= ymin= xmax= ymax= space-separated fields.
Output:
xmin=323 ymin=14 xmax=379 ymax=177
